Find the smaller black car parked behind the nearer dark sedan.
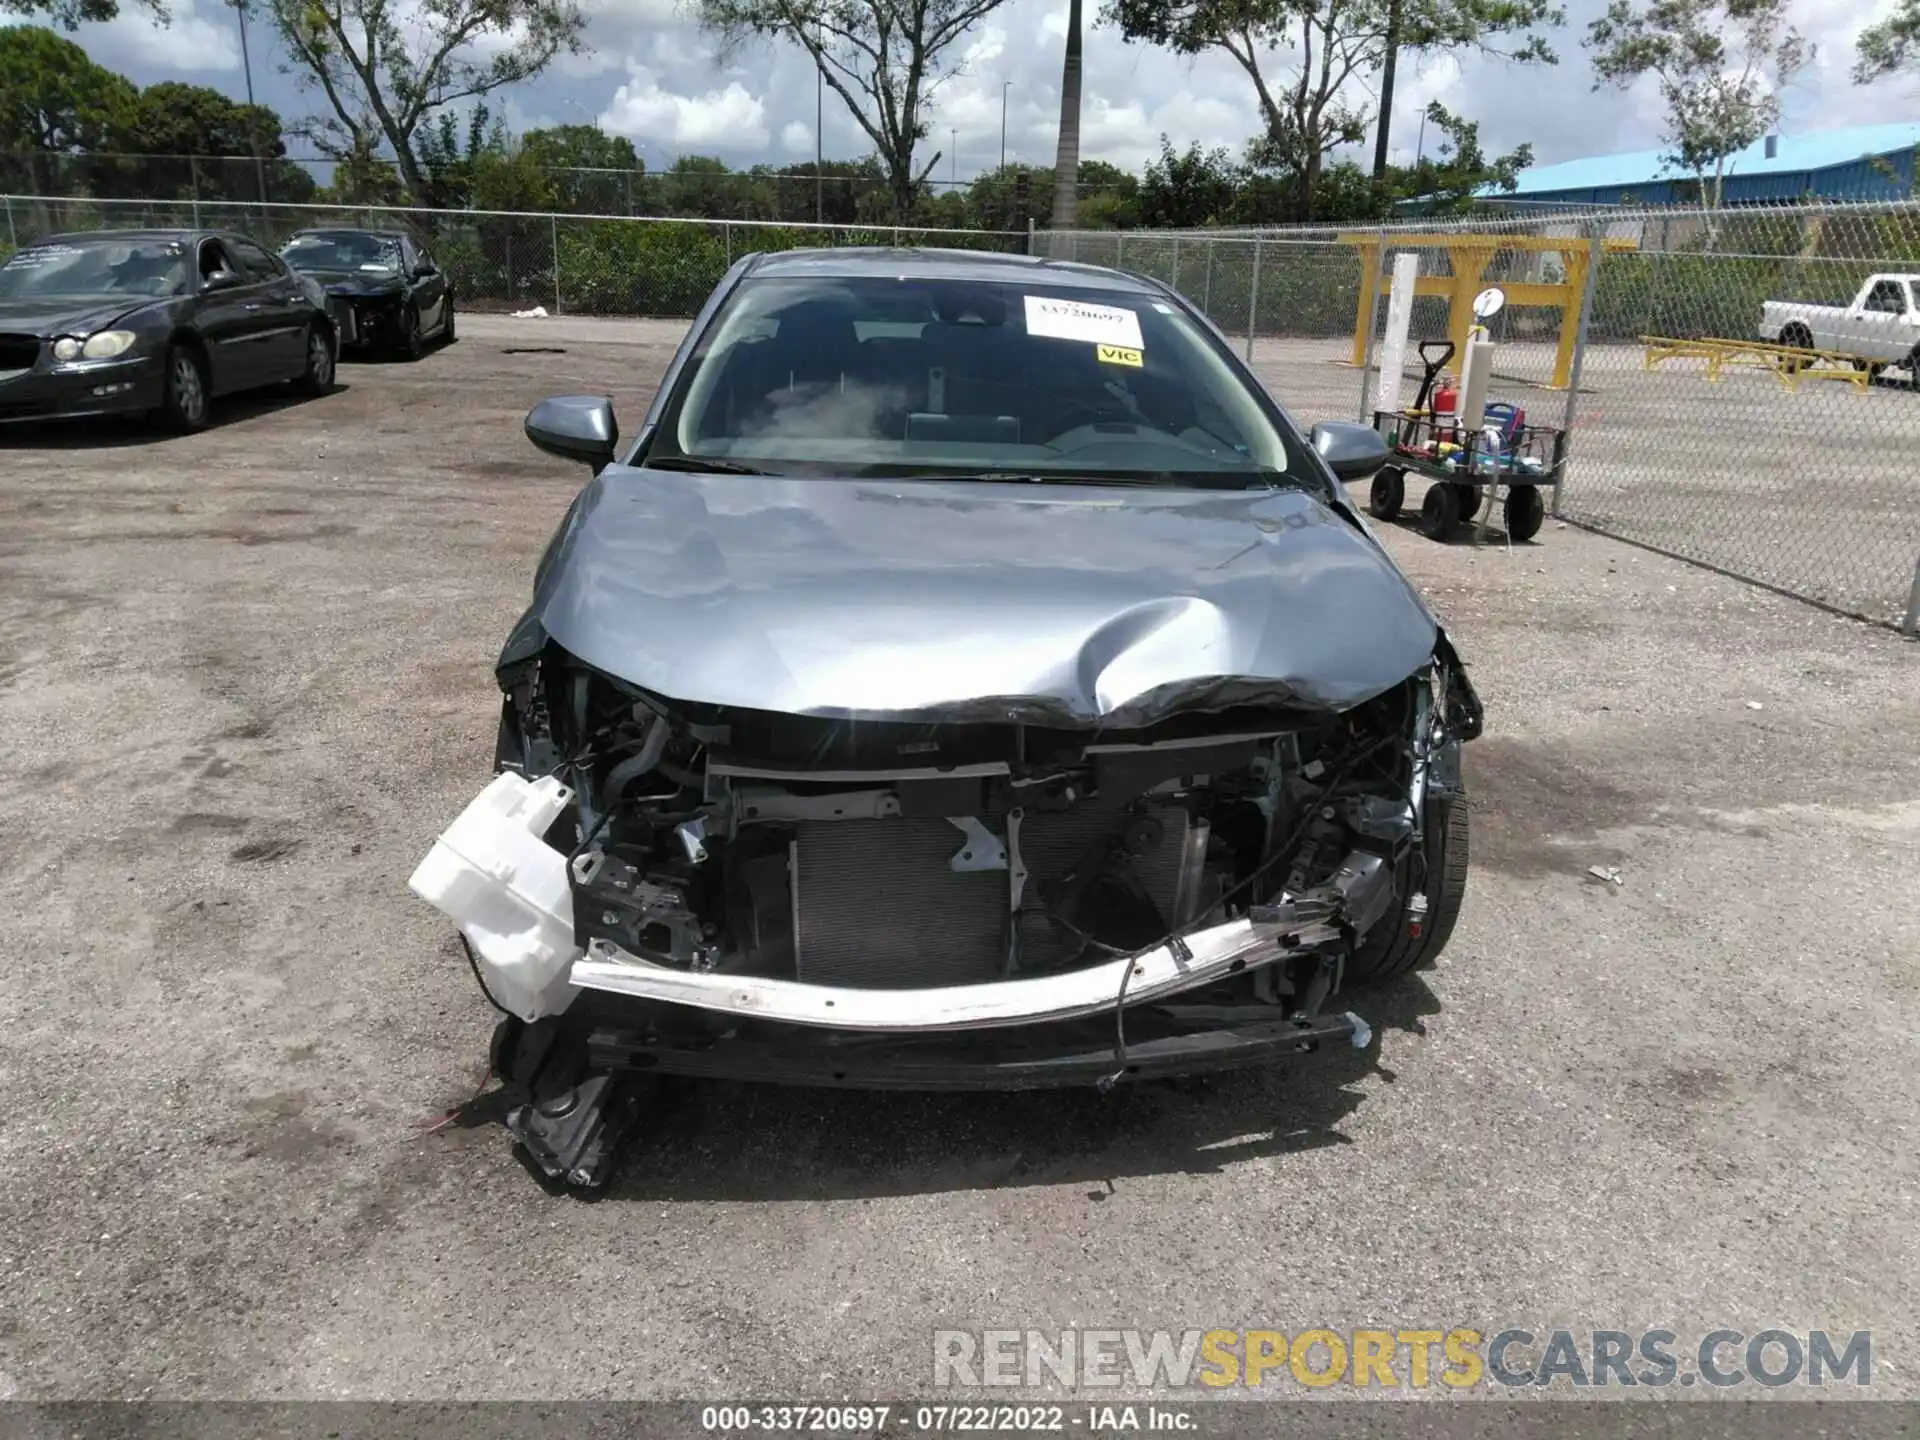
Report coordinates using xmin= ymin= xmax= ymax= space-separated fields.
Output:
xmin=280 ymin=230 xmax=453 ymax=359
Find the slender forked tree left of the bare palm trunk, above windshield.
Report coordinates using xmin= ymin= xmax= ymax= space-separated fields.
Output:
xmin=691 ymin=0 xmax=1006 ymax=221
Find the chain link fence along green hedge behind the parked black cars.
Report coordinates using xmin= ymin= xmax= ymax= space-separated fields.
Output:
xmin=0 ymin=196 xmax=1029 ymax=317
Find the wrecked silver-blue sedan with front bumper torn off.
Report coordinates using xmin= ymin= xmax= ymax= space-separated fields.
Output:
xmin=413 ymin=250 xmax=1480 ymax=1185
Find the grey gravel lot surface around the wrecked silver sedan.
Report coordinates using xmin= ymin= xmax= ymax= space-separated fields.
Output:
xmin=0 ymin=317 xmax=1920 ymax=1398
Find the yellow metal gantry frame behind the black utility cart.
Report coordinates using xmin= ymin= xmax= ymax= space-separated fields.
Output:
xmin=1340 ymin=230 xmax=1638 ymax=390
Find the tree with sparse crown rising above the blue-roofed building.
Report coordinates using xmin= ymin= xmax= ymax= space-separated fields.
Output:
xmin=1586 ymin=0 xmax=1812 ymax=209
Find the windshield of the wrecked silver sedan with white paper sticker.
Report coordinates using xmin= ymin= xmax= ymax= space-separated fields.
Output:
xmin=643 ymin=273 xmax=1313 ymax=488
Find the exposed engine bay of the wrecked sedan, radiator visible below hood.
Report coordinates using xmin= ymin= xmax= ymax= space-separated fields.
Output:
xmin=480 ymin=633 xmax=1476 ymax=1029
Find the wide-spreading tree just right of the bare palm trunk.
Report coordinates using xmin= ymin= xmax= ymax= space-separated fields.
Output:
xmin=1108 ymin=0 xmax=1563 ymax=219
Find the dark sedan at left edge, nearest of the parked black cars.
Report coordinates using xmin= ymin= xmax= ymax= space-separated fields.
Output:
xmin=0 ymin=230 xmax=338 ymax=430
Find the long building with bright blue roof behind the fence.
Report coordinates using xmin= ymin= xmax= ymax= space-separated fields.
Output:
xmin=1482 ymin=123 xmax=1920 ymax=205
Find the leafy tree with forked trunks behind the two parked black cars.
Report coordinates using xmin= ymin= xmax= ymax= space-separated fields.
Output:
xmin=267 ymin=0 xmax=586 ymax=205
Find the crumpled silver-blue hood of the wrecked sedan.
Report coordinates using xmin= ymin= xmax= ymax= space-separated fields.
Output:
xmin=526 ymin=467 xmax=1438 ymax=728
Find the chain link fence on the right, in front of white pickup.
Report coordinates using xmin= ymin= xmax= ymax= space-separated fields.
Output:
xmin=1039 ymin=204 xmax=1920 ymax=630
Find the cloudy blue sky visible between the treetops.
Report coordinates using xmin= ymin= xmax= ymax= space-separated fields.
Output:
xmin=41 ymin=0 xmax=1920 ymax=180
